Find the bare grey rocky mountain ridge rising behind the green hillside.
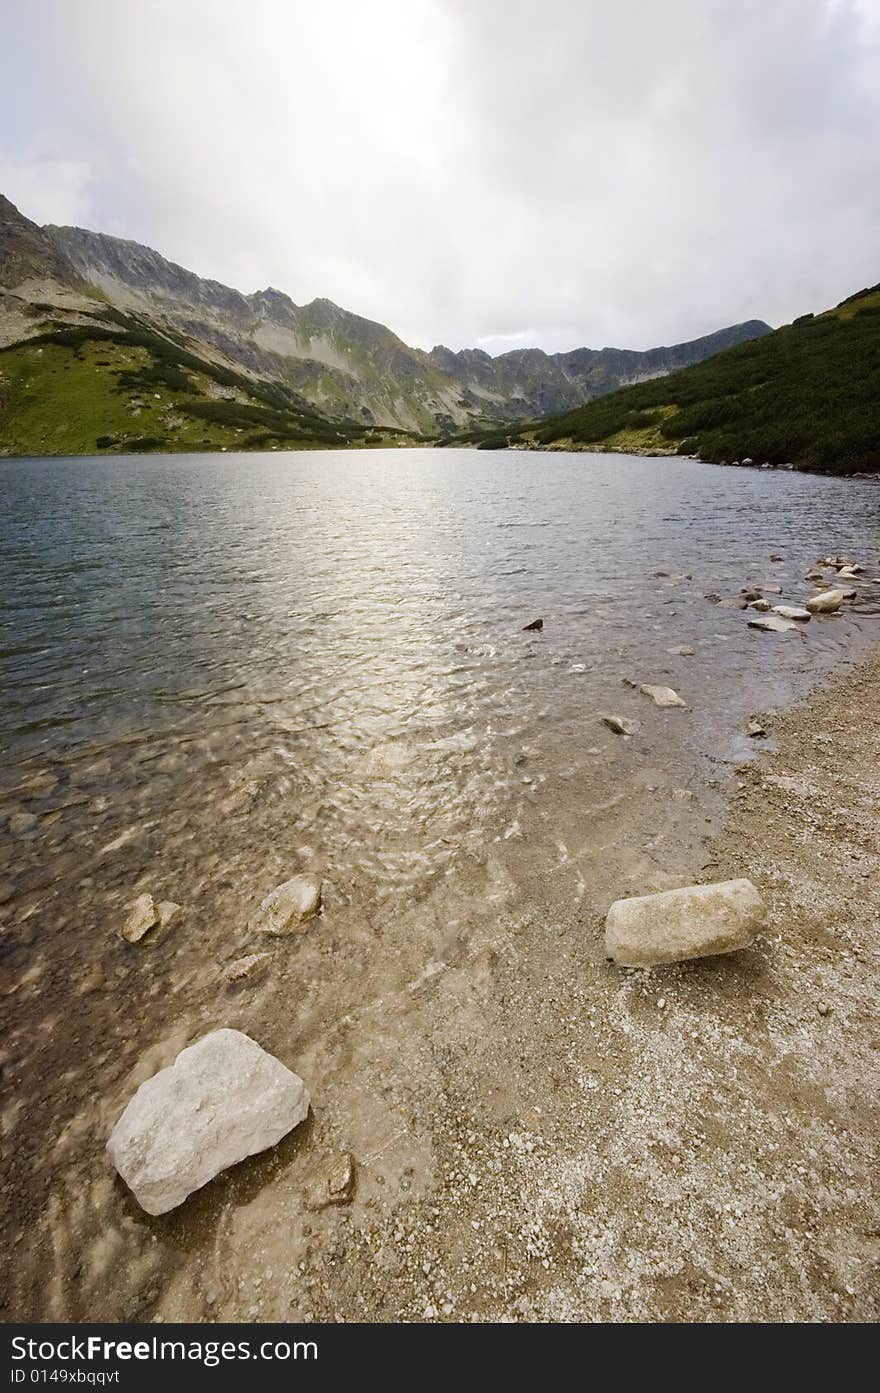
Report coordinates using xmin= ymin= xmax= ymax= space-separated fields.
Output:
xmin=0 ymin=199 xmax=770 ymax=435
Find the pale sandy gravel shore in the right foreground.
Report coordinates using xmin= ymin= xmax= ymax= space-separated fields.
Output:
xmin=153 ymin=657 xmax=880 ymax=1321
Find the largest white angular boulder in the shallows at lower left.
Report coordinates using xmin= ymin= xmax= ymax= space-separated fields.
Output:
xmin=107 ymin=1029 xmax=309 ymax=1215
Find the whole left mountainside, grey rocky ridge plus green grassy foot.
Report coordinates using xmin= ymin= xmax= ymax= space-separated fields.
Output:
xmin=0 ymin=196 xmax=770 ymax=454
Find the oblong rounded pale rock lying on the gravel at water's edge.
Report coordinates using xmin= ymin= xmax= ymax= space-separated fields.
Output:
xmin=606 ymin=880 xmax=764 ymax=967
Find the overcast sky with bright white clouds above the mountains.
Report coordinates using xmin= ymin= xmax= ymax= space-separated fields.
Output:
xmin=0 ymin=0 xmax=880 ymax=352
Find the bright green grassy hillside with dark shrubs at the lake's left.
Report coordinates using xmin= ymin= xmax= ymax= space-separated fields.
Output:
xmin=0 ymin=308 xmax=420 ymax=456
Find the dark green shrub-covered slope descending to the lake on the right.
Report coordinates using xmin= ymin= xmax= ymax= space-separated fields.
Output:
xmin=504 ymin=286 xmax=880 ymax=474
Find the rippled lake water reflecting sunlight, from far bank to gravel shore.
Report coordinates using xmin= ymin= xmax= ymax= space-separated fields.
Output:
xmin=0 ymin=450 xmax=880 ymax=1314
